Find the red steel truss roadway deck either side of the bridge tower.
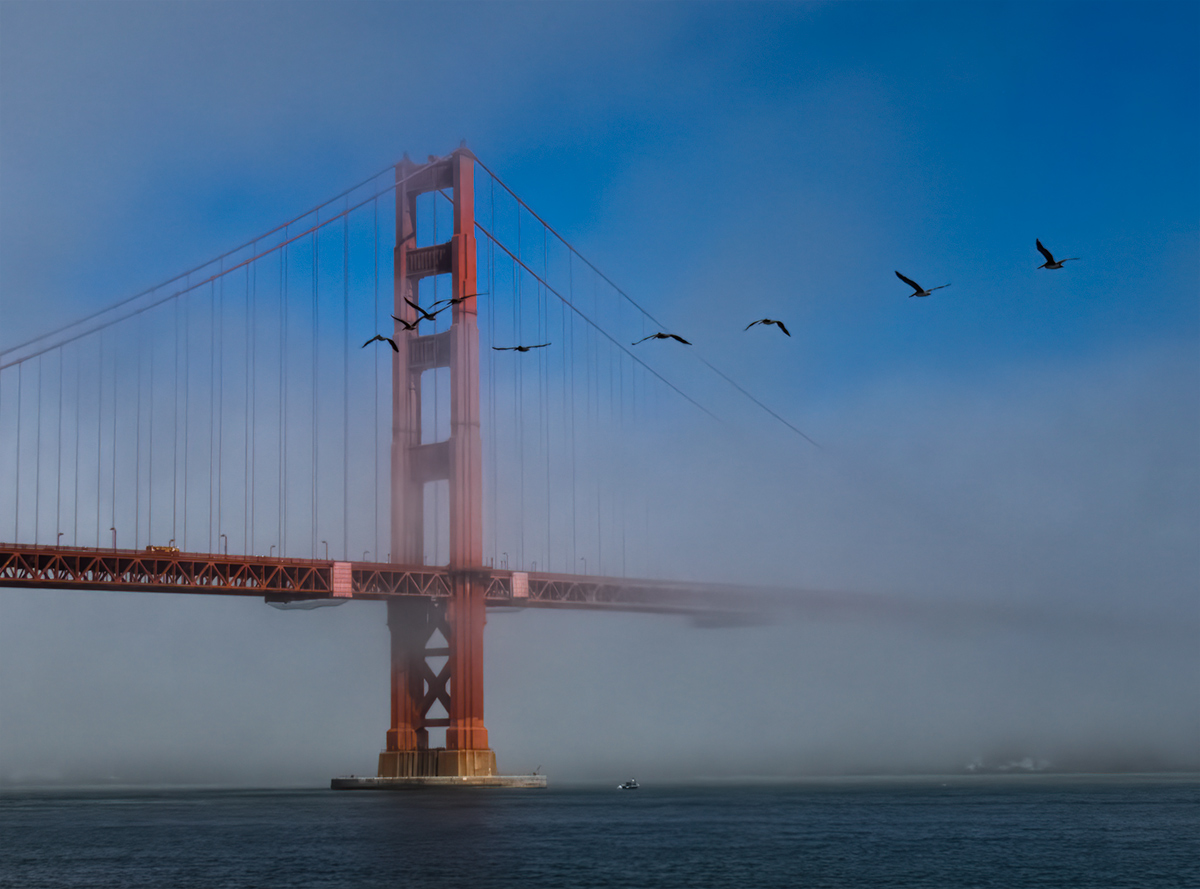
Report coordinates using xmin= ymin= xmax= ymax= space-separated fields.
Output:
xmin=0 ymin=543 xmax=762 ymax=619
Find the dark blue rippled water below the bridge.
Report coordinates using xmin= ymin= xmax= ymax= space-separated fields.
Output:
xmin=0 ymin=779 xmax=1200 ymax=889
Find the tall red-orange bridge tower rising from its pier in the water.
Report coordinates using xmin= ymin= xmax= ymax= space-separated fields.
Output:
xmin=379 ymin=146 xmax=496 ymax=777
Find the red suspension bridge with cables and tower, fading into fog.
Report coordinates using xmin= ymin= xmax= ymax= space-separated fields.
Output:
xmin=0 ymin=146 xmax=803 ymax=786
